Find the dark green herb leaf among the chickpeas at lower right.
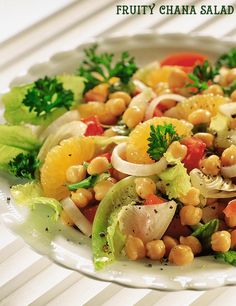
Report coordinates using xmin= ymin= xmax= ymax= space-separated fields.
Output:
xmin=192 ymin=219 xmax=219 ymax=250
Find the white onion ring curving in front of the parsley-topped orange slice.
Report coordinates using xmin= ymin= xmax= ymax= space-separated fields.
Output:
xmin=111 ymin=143 xmax=167 ymax=176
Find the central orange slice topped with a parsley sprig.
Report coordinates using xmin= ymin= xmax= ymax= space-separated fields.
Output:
xmin=126 ymin=117 xmax=191 ymax=164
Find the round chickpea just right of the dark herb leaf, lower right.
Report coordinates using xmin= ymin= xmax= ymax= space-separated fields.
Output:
xmin=211 ymin=231 xmax=231 ymax=253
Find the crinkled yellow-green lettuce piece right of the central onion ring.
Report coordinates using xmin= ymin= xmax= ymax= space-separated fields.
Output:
xmin=159 ymin=152 xmax=191 ymax=200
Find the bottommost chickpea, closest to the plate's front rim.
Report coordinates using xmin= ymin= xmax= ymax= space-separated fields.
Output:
xmin=169 ymin=244 xmax=194 ymax=266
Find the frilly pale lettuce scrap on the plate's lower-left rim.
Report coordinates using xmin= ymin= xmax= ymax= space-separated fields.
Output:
xmin=11 ymin=181 xmax=62 ymax=221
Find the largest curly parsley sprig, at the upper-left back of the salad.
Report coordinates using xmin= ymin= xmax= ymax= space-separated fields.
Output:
xmin=77 ymin=45 xmax=138 ymax=92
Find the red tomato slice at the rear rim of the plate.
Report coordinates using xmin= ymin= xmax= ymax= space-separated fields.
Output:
xmin=160 ymin=52 xmax=207 ymax=67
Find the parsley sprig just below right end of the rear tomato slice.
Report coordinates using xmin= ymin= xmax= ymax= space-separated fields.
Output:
xmin=185 ymin=60 xmax=219 ymax=94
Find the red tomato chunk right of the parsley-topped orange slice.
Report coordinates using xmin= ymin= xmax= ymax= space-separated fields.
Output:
xmin=181 ymin=137 xmax=206 ymax=171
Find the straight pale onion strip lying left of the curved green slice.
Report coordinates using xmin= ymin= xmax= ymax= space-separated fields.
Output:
xmin=61 ymin=197 xmax=92 ymax=237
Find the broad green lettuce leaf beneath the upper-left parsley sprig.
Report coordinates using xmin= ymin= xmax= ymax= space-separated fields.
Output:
xmin=2 ymin=75 xmax=84 ymax=126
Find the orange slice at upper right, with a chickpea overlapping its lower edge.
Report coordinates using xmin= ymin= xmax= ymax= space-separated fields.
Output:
xmin=166 ymin=94 xmax=229 ymax=120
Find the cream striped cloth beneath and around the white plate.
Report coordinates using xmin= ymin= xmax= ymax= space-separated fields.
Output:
xmin=0 ymin=0 xmax=236 ymax=306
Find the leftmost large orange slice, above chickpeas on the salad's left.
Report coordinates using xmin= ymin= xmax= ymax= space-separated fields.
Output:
xmin=40 ymin=136 xmax=95 ymax=200
